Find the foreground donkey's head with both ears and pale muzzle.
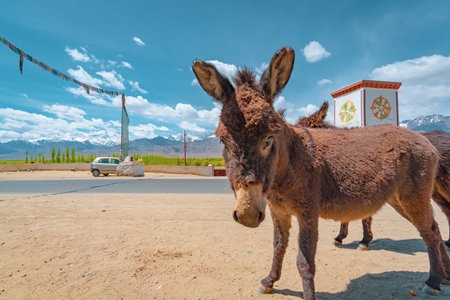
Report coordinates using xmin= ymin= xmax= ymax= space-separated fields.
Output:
xmin=192 ymin=47 xmax=295 ymax=227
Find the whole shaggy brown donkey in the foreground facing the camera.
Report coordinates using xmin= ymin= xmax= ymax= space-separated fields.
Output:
xmin=192 ymin=47 xmax=450 ymax=300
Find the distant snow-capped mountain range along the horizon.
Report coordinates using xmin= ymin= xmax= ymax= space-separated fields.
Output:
xmin=0 ymin=114 xmax=450 ymax=160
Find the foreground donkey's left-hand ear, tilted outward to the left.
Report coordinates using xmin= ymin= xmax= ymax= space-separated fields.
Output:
xmin=192 ymin=60 xmax=234 ymax=103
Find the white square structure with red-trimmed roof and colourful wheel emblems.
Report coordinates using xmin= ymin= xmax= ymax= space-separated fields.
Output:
xmin=331 ymin=80 xmax=402 ymax=127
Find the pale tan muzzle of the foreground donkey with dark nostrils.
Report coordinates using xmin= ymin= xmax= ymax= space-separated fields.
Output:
xmin=233 ymin=184 xmax=266 ymax=228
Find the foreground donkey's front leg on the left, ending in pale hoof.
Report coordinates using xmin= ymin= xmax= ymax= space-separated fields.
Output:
xmin=258 ymin=206 xmax=291 ymax=294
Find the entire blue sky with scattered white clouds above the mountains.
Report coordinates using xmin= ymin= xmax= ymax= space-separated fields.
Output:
xmin=0 ymin=0 xmax=450 ymax=142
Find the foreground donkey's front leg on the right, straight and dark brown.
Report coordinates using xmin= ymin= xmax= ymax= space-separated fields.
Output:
xmin=297 ymin=213 xmax=319 ymax=300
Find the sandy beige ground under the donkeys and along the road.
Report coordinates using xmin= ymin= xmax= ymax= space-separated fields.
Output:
xmin=0 ymin=171 xmax=450 ymax=300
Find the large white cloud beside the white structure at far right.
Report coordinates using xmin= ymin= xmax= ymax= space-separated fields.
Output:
xmin=369 ymin=55 xmax=450 ymax=120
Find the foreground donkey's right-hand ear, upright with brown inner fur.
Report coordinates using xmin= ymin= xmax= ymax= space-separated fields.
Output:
xmin=260 ymin=47 xmax=295 ymax=103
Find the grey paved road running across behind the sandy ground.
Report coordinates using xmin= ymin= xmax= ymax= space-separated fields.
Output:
xmin=0 ymin=178 xmax=232 ymax=195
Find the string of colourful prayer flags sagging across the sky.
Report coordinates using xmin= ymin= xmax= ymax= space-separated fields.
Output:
xmin=0 ymin=36 xmax=119 ymax=96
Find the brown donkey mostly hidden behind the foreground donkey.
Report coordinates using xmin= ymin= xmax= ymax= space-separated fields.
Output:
xmin=296 ymin=101 xmax=450 ymax=250
